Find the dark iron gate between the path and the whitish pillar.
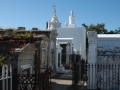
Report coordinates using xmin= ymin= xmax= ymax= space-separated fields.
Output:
xmin=72 ymin=57 xmax=88 ymax=90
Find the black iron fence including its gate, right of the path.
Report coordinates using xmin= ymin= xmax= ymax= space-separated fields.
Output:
xmin=73 ymin=62 xmax=120 ymax=90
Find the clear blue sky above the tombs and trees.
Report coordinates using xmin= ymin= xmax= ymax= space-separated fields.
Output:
xmin=0 ymin=0 xmax=120 ymax=30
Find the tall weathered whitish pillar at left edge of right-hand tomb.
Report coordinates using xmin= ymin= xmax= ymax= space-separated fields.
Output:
xmin=87 ymin=31 xmax=97 ymax=89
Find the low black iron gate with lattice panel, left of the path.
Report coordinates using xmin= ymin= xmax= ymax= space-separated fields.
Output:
xmin=13 ymin=69 xmax=51 ymax=90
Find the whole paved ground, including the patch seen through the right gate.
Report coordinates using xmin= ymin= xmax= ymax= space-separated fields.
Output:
xmin=51 ymin=71 xmax=87 ymax=90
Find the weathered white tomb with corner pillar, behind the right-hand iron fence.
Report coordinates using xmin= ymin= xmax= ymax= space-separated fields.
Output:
xmin=88 ymin=31 xmax=120 ymax=90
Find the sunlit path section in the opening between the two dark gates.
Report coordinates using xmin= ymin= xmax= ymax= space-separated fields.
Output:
xmin=51 ymin=71 xmax=73 ymax=90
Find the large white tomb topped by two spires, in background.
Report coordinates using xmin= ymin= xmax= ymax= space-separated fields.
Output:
xmin=47 ymin=7 xmax=86 ymax=59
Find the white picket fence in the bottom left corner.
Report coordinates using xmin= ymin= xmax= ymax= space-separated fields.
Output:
xmin=0 ymin=65 xmax=12 ymax=90
